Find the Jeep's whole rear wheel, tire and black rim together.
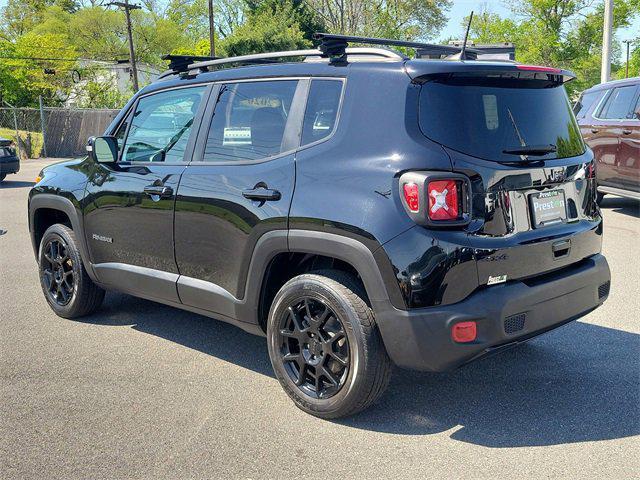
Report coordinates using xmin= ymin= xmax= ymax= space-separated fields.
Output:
xmin=267 ymin=270 xmax=391 ymax=419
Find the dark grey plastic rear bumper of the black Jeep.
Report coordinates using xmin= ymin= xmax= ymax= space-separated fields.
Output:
xmin=373 ymin=254 xmax=611 ymax=371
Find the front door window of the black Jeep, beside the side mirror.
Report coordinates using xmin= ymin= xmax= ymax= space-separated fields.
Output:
xmin=122 ymin=86 xmax=206 ymax=162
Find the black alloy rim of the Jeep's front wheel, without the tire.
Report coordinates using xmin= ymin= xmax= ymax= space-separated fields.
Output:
xmin=42 ymin=238 xmax=75 ymax=306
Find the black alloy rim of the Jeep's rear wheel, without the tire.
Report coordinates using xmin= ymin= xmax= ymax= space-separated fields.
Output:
xmin=277 ymin=297 xmax=350 ymax=399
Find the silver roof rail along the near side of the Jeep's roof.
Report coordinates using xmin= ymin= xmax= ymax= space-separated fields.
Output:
xmin=158 ymin=48 xmax=406 ymax=79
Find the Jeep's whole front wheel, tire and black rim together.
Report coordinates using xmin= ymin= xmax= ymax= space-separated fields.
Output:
xmin=38 ymin=224 xmax=105 ymax=318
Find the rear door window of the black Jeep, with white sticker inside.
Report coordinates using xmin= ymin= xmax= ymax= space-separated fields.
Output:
xmin=203 ymin=80 xmax=298 ymax=162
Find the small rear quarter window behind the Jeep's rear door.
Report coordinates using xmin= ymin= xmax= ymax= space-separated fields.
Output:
xmin=302 ymin=80 xmax=343 ymax=145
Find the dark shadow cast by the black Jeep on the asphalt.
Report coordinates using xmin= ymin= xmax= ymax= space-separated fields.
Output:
xmin=84 ymin=293 xmax=640 ymax=448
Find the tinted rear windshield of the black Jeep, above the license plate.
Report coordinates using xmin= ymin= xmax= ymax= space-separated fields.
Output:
xmin=419 ymin=76 xmax=585 ymax=162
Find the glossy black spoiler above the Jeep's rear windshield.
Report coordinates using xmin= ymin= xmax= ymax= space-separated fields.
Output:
xmin=405 ymin=60 xmax=576 ymax=84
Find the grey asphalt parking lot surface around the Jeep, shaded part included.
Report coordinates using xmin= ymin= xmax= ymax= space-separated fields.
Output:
xmin=0 ymin=160 xmax=640 ymax=479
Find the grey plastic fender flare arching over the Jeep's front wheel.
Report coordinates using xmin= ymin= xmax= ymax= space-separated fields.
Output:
xmin=29 ymin=193 xmax=96 ymax=281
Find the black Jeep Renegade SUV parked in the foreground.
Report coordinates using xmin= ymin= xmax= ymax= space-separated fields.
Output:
xmin=29 ymin=39 xmax=610 ymax=418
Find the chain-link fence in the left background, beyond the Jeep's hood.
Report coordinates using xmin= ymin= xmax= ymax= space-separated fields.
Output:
xmin=0 ymin=103 xmax=118 ymax=159
